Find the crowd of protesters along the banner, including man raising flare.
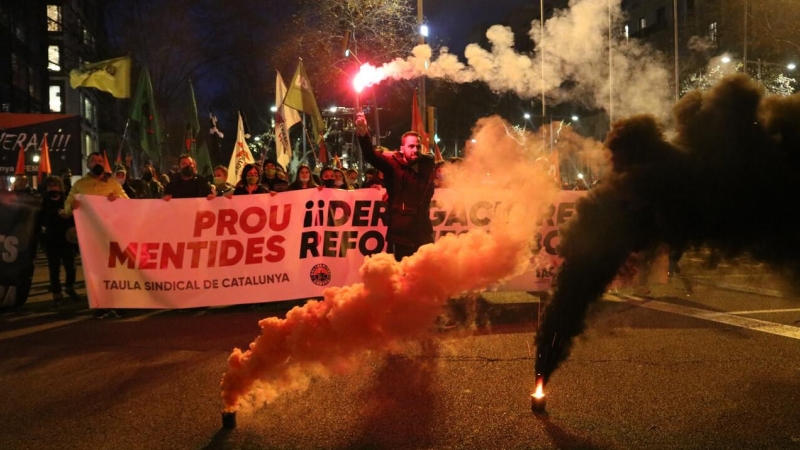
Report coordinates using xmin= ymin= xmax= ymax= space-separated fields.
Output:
xmin=6 ymin=134 xmax=600 ymax=317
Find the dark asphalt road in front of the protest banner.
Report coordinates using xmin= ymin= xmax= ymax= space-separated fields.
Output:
xmin=0 ymin=251 xmax=800 ymax=449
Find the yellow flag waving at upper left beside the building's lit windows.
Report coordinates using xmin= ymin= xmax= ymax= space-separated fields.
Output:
xmin=69 ymin=56 xmax=131 ymax=98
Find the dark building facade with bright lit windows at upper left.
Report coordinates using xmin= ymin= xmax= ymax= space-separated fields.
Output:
xmin=0 ymin=0 xmax=112 ymax=185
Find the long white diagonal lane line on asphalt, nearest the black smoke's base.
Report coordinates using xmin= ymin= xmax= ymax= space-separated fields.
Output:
xmin=604 ymin=295 xmax=800 ymax=340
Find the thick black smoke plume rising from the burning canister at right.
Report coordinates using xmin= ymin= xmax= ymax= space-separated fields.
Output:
xmin=536 ymin=75 xmax=800 ymax=380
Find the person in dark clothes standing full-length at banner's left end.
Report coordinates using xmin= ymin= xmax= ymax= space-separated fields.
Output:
xmin=38 ymin=176 xmax=79 ymax=306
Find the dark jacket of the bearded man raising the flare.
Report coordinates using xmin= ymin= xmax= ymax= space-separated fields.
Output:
xmin=358 ymin=135 xmax=436 ymax=246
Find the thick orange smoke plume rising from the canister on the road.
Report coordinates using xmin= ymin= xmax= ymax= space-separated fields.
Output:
xmin=221 ymin=117 xmax=557 ymax=411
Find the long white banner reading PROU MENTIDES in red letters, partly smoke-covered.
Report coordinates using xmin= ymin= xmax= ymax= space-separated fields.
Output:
xmin=75 ymin=189 xmax=585 ymax=309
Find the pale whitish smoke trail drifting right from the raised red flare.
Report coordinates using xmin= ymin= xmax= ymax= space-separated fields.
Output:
xmin=356 ymin=0 xmax=672 ymax=117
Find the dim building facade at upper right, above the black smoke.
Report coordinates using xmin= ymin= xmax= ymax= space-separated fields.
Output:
xmin=621 ymin=0 xmax=800 ymax=95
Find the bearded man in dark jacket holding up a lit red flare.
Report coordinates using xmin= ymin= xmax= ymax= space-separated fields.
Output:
xmin=356 ymin=113 xmax=435 ymax=261
